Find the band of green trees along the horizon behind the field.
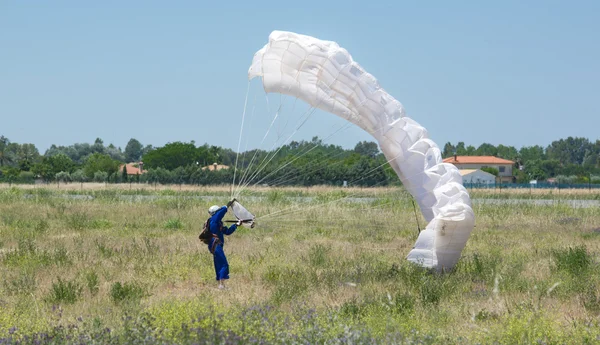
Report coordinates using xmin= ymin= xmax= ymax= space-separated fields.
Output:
xmin=0 ymin=136 xmax=600 ymax=186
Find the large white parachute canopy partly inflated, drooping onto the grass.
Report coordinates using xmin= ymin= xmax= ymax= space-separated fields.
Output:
xmin=248 ymin=31 xmax=475 ymax=270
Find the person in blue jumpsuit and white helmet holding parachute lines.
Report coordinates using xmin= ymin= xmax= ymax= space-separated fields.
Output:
xmin=199 ymin=199 xmax=242 ymax=289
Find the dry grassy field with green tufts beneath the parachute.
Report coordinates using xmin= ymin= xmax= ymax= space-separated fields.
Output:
xmin=0 ymin=184 xmax=600 ymax=344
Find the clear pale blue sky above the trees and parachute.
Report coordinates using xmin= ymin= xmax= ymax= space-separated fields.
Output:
xmin=0 ymin=1 xmax=600 ymax=153
